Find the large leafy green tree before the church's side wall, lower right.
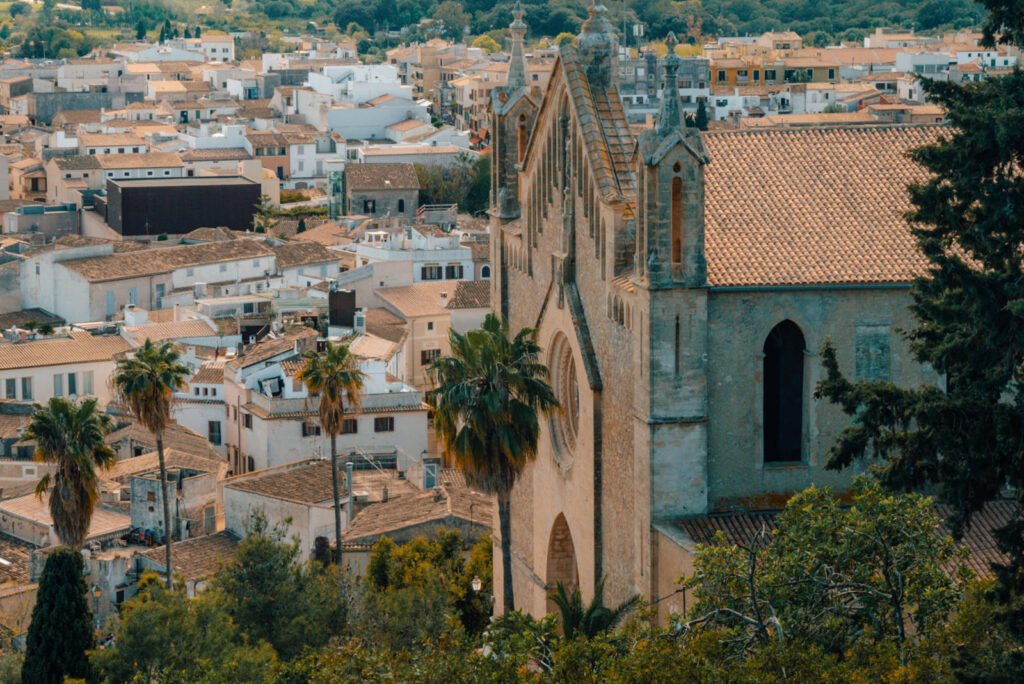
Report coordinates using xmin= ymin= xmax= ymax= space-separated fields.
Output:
xmin=686 ymin=476 xmax=967 ymax=662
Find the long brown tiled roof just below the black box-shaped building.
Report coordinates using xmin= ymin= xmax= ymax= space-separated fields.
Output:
xmin=60 ymin=240 xmax=273 ymax=283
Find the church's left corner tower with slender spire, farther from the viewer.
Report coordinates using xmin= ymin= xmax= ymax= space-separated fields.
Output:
xmin=490 ymin=0 xmax=541 ymax=316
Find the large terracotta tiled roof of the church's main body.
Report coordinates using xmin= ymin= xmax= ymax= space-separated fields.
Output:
xmin=703 ymin=126 xmax=941 ymax=286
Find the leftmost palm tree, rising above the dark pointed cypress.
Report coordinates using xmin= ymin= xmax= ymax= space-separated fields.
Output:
xmin=22 ymin=396 xmax=115 ymax=549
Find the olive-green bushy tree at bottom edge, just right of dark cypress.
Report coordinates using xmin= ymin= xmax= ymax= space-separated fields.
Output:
xmin=90 ymin=572 xmax=276 ymax=684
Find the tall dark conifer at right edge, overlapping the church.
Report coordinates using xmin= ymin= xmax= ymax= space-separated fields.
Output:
xmin=816 ymin=0 xmax=1024 ymax=636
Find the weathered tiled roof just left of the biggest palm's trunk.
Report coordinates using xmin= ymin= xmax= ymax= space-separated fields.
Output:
xmin=342 ymin=485 xmax=494 ymax=543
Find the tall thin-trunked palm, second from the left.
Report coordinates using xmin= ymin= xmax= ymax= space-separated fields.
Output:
xmin=112 ymin=339 xmax=189 ymax=589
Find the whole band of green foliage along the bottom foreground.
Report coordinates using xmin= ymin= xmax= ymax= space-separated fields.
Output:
xmin=79 ymin=478 xmax=1024 ymax=684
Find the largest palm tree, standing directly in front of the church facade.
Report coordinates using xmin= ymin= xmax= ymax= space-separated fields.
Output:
xmin=427 ymin=313 xmax=558 ymax=611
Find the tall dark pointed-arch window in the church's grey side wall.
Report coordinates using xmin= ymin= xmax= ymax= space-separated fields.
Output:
xmin=763 ymin=320 xmax=805 ymax=463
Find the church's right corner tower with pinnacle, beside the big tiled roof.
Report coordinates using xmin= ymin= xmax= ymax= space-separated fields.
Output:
xmin=633 ymin=35 xmax=708 ymax=521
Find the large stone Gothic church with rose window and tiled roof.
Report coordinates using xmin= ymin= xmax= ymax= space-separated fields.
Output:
xmin=490 ymin=5 xmax=938 ymax=614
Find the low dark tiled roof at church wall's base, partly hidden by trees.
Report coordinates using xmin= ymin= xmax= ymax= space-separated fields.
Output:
xmin=675 ymin=501 xmax=1017 ymax=578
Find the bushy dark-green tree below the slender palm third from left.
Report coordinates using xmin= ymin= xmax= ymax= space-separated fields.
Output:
xmin=211 ymin=514 xmax=348 ymax=658
